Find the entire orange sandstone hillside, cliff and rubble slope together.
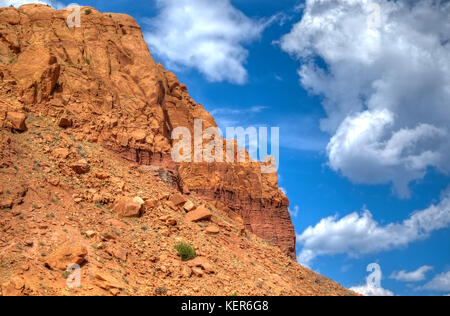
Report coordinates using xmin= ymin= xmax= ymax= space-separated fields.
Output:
xmin=0 ymin=5 xmax=351 ymax=295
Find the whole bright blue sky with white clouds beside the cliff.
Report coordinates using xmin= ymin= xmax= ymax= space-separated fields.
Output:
xmin=4 ymin=0 xmax=450 ymax=295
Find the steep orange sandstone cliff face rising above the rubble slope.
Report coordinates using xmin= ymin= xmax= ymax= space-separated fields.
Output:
xmin=0 ymin=5 xmax=295 ymax=257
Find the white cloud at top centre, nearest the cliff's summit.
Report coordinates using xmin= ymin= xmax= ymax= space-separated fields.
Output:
xmin=145 ymin=0 xmax=270 ymax=84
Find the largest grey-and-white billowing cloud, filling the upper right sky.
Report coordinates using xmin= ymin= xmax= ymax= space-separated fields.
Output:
xmin=280 ymin=0 xmax=450 ymax=197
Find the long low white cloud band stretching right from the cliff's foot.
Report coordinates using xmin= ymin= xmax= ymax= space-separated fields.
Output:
xmin=297 ymin=190 xmax=450 ymax=265
